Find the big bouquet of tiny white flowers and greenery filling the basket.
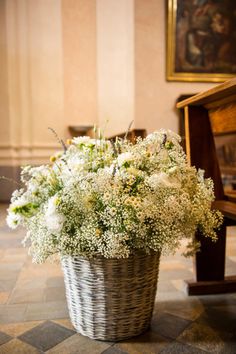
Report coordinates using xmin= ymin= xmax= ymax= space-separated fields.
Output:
xmin=7 ymin=130 xmax=222 ymax=263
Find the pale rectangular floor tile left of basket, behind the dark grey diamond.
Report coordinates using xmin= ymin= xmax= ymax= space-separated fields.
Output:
xmin=25 ymin=301 xmax=69 ymax=321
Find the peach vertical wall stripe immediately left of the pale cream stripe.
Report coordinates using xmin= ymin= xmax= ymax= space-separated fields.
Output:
xmin=61 ymin=0 xmax=98 ymax=125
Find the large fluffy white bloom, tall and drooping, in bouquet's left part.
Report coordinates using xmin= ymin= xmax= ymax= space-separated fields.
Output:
xmin=45 ymin=195 xmax=65 ymax=233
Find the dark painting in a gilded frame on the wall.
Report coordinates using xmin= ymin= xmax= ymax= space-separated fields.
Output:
xmin=166 ymin=0 xmax=236 ymax=82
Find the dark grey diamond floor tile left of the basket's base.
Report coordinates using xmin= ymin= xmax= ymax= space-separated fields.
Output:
xmin=18 ymin=321 xmax=75 ymax=351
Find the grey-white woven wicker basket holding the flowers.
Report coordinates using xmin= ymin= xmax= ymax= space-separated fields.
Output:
xmin=61 ymin=253 xmax=160 ymax=341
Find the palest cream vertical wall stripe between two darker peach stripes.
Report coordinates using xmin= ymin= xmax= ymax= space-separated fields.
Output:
xmin=97 ymin=0 xmax=135 ymax=135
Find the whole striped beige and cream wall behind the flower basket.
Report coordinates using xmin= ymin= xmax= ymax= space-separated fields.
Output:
xmin=0 ymin=0 xmax=220 ymax=166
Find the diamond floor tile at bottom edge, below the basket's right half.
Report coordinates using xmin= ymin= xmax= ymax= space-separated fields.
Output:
xmin=113 ymin=330 xmax=169 ymax=354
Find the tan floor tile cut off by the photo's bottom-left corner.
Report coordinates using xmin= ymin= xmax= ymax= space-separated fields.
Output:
xmin=0 ymin=339 xmax=42 ymax=354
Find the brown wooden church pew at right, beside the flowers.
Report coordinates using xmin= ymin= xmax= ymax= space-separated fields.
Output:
xmin=177 ymin=78 xmax=236 ymax=295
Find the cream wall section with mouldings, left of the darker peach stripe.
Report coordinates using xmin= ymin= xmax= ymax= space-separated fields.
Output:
xmin=0 ymin=0 xmax=66 ymax=165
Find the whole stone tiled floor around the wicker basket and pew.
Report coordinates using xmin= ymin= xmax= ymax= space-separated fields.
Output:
xmin=0 ymin=205 xmax=236 ymax=354
